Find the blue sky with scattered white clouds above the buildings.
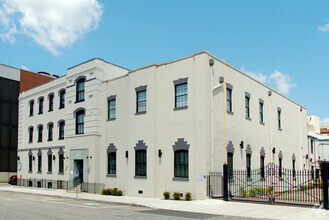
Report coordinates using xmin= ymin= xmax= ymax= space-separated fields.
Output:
xmin=0 ymin=0 xmax=329 ymax=125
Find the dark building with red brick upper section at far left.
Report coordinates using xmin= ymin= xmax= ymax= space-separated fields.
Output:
xmin=0 ymin=64 xmax=53 ymax=182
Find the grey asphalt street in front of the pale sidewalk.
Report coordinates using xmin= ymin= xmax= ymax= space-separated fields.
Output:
xmin=0 ymin=191 xmax=256 ymax=220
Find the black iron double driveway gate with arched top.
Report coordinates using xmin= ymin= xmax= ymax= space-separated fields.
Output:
xmin=224 ymin=163 xmax=322 ymax=206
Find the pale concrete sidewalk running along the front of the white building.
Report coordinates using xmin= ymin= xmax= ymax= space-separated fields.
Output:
xmin=0 ymin=184 xmax=329 ymax=220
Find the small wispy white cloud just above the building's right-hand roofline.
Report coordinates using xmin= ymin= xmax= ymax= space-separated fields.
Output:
xmin=241 ymin=67 xmax=297 ymax=95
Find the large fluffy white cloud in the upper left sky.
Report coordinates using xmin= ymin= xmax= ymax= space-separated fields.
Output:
xmin=0 ymin=0 xmax=103 ymax=55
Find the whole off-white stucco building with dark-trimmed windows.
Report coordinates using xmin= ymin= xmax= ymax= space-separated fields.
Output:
xmin=18 ymin=51 xmax=308 ymax=199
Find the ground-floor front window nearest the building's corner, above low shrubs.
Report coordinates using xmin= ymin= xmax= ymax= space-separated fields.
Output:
xmin=174 ymin=150 xmax=188 ymax=178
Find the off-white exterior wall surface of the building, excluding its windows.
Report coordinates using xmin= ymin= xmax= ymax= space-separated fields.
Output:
xmin=19 ymin=51 xmax=307 ymax=199
